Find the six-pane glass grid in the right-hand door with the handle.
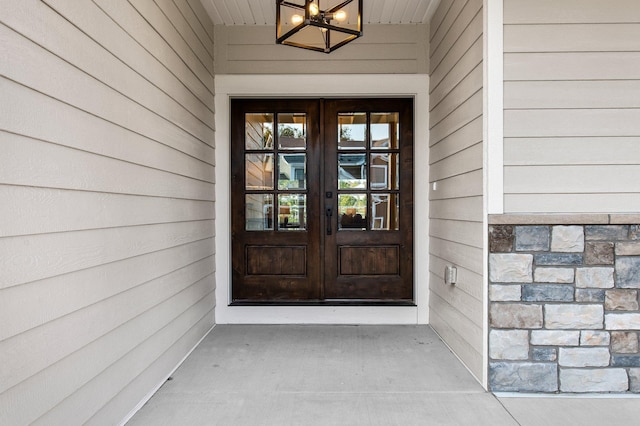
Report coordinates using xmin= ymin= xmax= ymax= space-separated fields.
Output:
xmin=337 ymin=112 xmax=400 ymax=231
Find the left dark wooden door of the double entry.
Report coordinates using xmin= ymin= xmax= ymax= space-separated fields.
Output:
xmin=231 ymin=100 xmax=321 ymax=302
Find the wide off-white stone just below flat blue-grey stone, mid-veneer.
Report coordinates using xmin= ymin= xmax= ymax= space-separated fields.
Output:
xmin=544 ymin=304 xmax=604 ymax=330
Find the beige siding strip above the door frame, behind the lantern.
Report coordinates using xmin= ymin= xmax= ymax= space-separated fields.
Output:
xmin=215 ymin=24 xmax=428 ymax=74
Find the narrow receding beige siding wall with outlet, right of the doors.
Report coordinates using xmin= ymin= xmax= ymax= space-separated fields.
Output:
xmin=429 ymin=0 xmax=483 ymax=378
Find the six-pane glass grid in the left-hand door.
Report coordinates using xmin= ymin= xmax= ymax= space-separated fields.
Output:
xmin=244 ymin=113 xmax=307 ymax=231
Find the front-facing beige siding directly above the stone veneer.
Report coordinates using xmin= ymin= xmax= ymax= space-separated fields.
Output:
xmin=504 ymin=0 xmax=640 ymax=213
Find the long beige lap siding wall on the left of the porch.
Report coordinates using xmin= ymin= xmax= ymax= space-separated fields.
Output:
xmin=0 ymin=0 xmax=215 ymax=425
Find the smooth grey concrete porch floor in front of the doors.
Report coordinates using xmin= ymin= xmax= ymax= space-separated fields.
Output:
xmin=127 ymin=325 xmax=640 ymax=426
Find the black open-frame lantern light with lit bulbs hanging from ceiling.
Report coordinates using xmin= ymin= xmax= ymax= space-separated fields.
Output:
xmin=276 ymin=0 xmax=362 ymax=53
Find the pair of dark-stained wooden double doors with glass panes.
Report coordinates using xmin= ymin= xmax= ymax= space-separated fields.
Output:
xmin=231 ymin=99 xmax=414 ymax=304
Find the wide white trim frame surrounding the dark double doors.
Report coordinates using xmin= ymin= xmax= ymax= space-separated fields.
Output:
xmin=215 ymin=74 xmax=429 ymax=324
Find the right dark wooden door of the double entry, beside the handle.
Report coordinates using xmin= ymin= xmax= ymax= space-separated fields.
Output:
xmin=323 ymin=99 xmax=413 ymax=300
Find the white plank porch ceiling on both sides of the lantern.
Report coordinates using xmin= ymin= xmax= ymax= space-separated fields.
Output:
xmin=201 ymin=0 xmax=440 ymax=25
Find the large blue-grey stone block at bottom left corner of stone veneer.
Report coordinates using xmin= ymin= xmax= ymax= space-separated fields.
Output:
xmin=489 ymin=362 xmax=558 ymax=392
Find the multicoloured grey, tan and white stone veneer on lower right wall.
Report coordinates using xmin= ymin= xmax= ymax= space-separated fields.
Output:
xmin=489 ymin=225 xmax=640 ymax=392
